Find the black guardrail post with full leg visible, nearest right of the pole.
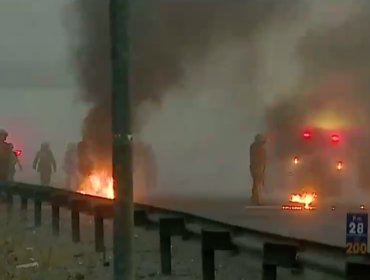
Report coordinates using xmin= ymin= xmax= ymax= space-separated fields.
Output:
xmin=159 ymin=218 xmax=186 ymax=275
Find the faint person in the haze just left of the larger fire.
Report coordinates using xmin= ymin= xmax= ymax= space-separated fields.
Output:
xmin=63 ymin=143 xmax=78 ymax=190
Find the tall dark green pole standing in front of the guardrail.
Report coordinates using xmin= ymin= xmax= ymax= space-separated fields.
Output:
xmin=109 ymin=0 xmax=135 ymax=280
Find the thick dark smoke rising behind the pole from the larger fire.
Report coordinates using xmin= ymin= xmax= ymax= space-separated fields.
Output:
xmin=66 ymin=0 xmax=295 ymax=164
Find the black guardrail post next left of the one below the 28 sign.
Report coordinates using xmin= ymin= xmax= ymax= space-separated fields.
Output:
xmin=262 ymin=243 xmax=299 ymax=280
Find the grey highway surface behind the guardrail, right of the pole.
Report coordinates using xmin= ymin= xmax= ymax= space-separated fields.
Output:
xmin=140 ymin=196 xmax=368 ymax=247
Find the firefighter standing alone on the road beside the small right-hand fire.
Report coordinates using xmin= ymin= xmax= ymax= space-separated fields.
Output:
xmin=249 ymin=134 xmax=266 ymax=205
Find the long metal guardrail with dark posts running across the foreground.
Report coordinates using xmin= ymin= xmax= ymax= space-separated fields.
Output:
xmin=0 ymin=183 xmax=370 ymax=280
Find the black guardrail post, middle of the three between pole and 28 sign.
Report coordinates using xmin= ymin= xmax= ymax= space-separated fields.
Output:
xmin=202 ymin=230 xmax=236 ymax=280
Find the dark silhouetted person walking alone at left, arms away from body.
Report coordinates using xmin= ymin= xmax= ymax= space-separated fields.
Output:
xmin=33 ymin=143 xmax=57 ymax=186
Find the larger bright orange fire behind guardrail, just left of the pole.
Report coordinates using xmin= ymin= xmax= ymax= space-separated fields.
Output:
xmin=78 ymin=171 xmax=114 ymax=199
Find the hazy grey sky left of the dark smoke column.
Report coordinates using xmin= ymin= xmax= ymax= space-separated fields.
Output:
xmin=0 ymin=0 xmax=85 ymax=183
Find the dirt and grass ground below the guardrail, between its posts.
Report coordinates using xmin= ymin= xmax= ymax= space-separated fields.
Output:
xmin=0 ymin=200 xmax=338 ymax=280
